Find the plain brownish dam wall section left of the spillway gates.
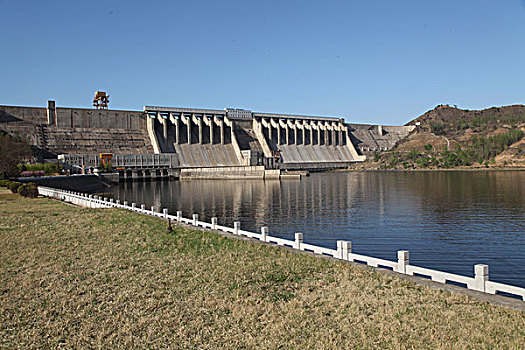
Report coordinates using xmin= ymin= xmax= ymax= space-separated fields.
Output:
xmin=0 ymin=101 xmax=153 ymax=158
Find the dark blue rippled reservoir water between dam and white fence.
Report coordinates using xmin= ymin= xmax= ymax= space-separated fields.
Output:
xmin=108 ymin=171 xmax=525 ymax=287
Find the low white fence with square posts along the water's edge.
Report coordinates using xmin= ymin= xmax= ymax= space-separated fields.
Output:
xmin=38 ymin=186 xmax=525 ymax=300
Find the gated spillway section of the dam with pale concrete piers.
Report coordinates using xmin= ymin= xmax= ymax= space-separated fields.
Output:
xmin=144 ymin=106 xmax=364 ymax=170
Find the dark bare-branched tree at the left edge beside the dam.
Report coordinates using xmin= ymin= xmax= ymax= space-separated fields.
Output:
xmin=0 ymin=133 xmax=32 ymax=177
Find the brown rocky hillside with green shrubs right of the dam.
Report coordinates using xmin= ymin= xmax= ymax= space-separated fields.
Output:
xmin=363 ymin=105 xmax=525 ymax=169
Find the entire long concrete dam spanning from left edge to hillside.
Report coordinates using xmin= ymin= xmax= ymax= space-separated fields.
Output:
xmin=0 ymin=101 xmax=414 ymax=177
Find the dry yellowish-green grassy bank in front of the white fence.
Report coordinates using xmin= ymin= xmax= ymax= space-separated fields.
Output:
xmin=0 ymin=192 xmax=525 ymax=349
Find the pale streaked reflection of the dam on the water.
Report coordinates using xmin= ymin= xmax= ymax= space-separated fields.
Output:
xmin=115 ymin=177 xmax=360 ymax=234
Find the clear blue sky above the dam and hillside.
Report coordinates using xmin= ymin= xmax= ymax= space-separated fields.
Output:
xmin=0 ymin=0 xmax=525 ymax=125
